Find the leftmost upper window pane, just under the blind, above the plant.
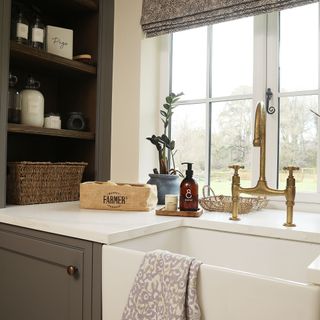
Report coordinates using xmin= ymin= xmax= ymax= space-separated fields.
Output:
xmin=172 ymin=27 xmax=207 ymax=100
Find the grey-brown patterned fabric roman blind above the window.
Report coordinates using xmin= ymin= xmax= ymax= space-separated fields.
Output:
xmin=141 ymin=0 xmax=318 ymax=37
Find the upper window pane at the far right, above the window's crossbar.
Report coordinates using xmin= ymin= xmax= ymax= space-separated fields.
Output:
xmin=280 ymin=3 xmax=319 ymax=92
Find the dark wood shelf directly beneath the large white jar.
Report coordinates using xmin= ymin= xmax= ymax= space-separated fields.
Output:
xmin=8 ymin=123 xmax=95 ymax=141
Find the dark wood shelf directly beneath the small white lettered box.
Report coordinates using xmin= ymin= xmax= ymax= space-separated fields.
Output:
xmin=10 ymin=41 xmax=97 ymax=76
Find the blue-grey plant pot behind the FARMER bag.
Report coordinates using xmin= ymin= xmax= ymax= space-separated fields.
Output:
xmin=147 ymin=173 xmax=180 ymax=204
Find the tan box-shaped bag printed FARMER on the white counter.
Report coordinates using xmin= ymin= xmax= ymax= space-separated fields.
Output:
xmin=80 ymin=181 xmax=158 ymax=211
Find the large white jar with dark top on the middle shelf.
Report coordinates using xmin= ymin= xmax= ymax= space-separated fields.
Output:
xmin=20 ymin=76 xmax=44 ymax=127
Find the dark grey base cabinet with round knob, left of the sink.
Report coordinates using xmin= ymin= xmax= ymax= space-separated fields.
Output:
xmin=0 ymin=224 xmax=101 ymax=320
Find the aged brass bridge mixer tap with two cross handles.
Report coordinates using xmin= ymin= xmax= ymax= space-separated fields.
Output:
xmin=229 ymin=102 xmax=299 ymax=227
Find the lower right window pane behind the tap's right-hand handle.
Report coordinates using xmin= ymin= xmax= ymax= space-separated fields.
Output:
xmin=279 ymin=96 xmax=319 ymax=192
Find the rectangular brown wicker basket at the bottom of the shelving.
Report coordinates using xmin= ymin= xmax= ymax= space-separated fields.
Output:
xmin=7 ymin=162 xmax=87 ymax=204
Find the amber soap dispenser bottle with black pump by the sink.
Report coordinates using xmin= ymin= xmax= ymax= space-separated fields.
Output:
xmin=179 ymin=162 xmax=198 ymax=211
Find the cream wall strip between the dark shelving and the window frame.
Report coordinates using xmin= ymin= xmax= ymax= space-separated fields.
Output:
xmin=111 ymin=0 xmax=160 ymax=182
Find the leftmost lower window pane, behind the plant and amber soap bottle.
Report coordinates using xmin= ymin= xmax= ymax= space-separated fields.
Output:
xmin=171 ymin=104 xmax=206 ymax=188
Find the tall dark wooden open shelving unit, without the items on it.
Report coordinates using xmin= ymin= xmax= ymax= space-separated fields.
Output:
xmin=0 ymin=0 xmax=114 ymax=208
